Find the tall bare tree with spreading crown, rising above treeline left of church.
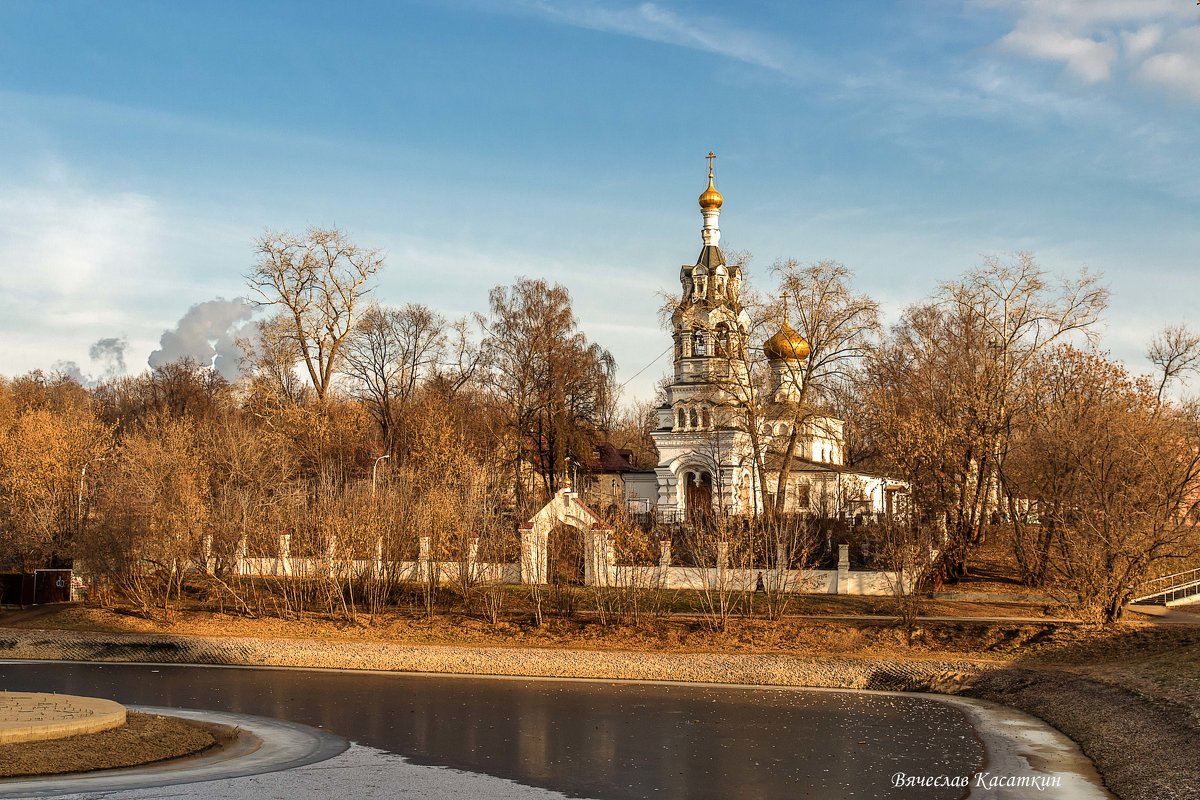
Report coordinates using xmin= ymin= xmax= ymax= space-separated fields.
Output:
xmin=247 ymin=228 xmax=383 ymax=403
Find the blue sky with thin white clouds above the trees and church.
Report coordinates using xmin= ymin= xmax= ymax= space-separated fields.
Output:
xmin=0 ymin=0 xmax=1200 ymax=398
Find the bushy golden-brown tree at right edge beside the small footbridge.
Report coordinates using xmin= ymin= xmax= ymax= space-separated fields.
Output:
xmin=1007 ymin=347 xmax=1200 ymax=621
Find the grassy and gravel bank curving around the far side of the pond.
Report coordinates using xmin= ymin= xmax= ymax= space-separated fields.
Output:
xmin=0 ymin=608 xmax=1200 ymax=800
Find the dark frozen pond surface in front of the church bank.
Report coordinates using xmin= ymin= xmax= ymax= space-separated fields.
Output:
xmin=0 ymin=663 xmax=984 ymax=799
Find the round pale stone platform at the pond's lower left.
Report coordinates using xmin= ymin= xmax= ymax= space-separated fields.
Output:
xmin=0 ymin=692 xmax=125 ymax=745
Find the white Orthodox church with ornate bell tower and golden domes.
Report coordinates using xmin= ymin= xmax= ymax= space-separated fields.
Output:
xmin=623 ymin=154 xmax=907 ymax=522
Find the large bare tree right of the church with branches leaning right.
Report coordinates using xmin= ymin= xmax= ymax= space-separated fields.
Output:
xmin=864 ymin=253 xmax=1108 ymax=579
